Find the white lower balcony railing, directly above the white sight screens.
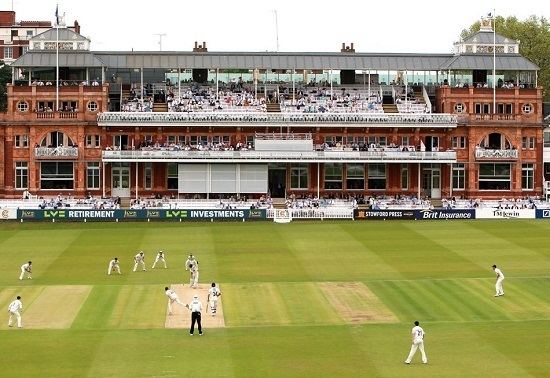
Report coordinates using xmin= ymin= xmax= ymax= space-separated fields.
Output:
xmin=103 ymin=150 xmax=456 ymax=163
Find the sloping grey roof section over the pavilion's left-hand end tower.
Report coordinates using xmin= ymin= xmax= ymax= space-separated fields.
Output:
xmin=13 ymin=50 xmax=105 ymax=68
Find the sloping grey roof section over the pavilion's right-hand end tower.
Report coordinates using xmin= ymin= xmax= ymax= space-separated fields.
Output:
xmin=441 ymin=54 xmax=539 ymax=71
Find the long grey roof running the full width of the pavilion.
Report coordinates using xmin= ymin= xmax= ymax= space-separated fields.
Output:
xmin=11 ymin=50 xmax=539 ymax=71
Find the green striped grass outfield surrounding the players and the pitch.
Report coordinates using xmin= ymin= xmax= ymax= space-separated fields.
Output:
xmin=0 ymin=220 xmax=550 ymax=377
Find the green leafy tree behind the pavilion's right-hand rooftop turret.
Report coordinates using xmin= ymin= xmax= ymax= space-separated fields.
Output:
xmin=461 ymin=16 xmax=550 ymax=101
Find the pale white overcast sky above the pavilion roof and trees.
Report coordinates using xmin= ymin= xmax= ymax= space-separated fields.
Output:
xmin=5 ymin=0 xmax=550 ymax=53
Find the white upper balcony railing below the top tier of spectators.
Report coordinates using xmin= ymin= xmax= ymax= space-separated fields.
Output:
xmin=97 ymin=112 xmax=457 ymax=128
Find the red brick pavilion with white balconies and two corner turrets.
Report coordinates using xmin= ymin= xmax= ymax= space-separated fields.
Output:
xmin=0 ymin=19 xmax=543 ymax=198
